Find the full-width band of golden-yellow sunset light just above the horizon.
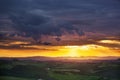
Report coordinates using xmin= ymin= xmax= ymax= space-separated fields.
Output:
xmin=0 ymin=44 xmax=120 ymax=57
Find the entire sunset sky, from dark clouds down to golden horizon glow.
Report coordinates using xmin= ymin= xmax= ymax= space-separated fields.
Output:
xmin=0 ymin=0 xmax=120 ymax=57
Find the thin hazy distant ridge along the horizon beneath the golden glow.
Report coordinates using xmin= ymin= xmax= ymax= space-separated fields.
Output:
xmin=0 ymin=56 xmax=120 ymax=62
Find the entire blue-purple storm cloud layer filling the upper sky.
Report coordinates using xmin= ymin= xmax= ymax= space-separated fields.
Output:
xmin=0 ymin=0 xmax=120 ymax=45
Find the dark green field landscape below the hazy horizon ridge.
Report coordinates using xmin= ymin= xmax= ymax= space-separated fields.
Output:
xmin=0 ymin=59 xmax=120 ymax=80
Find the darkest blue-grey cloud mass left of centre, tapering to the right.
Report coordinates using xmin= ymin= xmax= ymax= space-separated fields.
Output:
xmin=7 ymin=10 xmax=82 ymax=40
